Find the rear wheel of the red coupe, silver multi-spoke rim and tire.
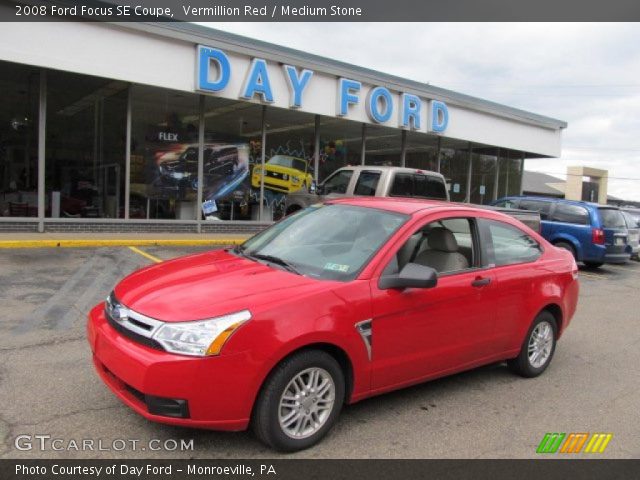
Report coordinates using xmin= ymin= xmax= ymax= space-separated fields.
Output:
xmin=507 ymin=310 xmax=558 ymax=378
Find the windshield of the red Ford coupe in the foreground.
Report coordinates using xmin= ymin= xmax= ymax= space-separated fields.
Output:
xmin=241 ymin=205 xmax=409 ymax=281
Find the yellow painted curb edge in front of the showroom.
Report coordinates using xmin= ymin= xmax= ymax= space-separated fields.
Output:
xmin=0 ymin=236 xmax=249 ymax=248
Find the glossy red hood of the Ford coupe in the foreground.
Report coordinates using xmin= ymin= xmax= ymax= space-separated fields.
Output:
xmin=115 ymin=250 xmax=324 ymax=322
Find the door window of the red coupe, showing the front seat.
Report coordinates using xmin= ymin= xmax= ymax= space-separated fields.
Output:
xmin=383 ymin=218 xmax=478 ymax=275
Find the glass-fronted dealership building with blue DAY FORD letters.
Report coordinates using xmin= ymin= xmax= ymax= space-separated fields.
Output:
xmin=0 ymin=19 xmax=567 ymax=233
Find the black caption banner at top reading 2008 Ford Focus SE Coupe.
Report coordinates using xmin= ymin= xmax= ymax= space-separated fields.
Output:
xmin=0 ymin=0 xmax=640 ymax=21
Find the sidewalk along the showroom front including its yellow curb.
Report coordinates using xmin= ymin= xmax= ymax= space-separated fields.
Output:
xmin=0 ymin=232 xmax=251 ymax=248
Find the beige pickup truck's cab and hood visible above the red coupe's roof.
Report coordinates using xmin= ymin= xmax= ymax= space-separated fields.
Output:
xmin=285 ymin=165 xmax=449 ymax=215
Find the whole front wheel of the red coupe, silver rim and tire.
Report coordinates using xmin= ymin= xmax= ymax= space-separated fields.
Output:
xmin=252 ymin=350 xmax=345 ymax=452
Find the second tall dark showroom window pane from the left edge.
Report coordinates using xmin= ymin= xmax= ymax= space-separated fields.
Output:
xmin=45 ymin=71 xmax=128 ymax=218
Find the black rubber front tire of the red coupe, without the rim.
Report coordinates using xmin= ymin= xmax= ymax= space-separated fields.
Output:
xmin=251 ymin=350 xmax=345 ymax=452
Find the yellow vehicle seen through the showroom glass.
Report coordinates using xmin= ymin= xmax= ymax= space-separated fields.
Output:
xmin=251 ymin=155 xmax=313 ymax=193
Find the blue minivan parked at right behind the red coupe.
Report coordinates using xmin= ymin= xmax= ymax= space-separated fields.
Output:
xmin=493 ymin=196 xmax=630 ymax=268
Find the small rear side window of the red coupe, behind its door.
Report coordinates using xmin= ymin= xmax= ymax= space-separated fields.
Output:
xmin=486 ymin=220 xmax=542 ymax=267
